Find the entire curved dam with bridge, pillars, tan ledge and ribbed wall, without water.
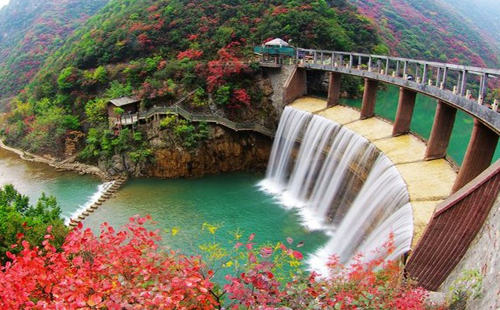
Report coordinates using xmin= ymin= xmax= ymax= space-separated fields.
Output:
xmin=260 ymin=48 xmax=500 ymax=308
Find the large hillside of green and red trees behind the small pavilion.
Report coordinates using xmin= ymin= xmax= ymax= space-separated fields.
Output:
xmin=3 ymin=0 xmax=379 ymax=157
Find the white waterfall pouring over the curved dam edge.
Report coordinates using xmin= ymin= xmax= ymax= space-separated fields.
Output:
xmin=261 ymin=107 xmax=413 ymax=274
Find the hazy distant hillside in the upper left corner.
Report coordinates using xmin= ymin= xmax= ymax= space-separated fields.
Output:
xmin=0 ymin=0 xmax=108 ymax=98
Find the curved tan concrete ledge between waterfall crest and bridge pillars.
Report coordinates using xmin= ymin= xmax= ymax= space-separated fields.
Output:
xmin=289 ymin=97 xmax=457 ymax=245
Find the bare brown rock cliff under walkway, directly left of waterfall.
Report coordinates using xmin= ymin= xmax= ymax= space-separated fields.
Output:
xmin=145 ymin=126 xmax=272 ymax=178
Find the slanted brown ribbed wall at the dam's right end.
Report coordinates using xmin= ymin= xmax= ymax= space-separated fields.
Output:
xmin=406 ymin=162 xmax=500 ymax=294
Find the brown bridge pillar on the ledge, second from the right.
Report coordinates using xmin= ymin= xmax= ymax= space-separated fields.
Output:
xmin=425 ymin=100 xmax=457 ymax=160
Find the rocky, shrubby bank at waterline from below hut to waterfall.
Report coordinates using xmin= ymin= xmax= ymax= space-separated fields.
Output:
xmin=99 ymin=122 xmax=272 ymax=178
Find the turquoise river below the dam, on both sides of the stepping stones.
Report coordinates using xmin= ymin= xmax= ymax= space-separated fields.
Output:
xmin=0 ymin=149 xmax=328 ymax=260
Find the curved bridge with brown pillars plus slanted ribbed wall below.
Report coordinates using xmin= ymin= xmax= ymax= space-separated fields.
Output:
xmin=261 ymin=48 xmax=500 ymax=290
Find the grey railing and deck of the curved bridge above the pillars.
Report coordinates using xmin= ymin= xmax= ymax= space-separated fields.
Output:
xmin=297 ymin=49 xmax=500 ymax=134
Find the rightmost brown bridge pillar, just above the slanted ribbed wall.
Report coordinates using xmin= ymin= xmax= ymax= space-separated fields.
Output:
xmin=452 ymin=119 xmax=498 ymax=193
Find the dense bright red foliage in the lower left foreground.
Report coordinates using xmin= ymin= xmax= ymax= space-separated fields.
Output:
xmin=0 ymin=218 xmax=218 ymax=310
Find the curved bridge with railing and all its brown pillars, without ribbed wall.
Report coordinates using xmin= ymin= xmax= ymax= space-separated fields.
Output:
xmin=283 ymin=48 xmax=500 ymax=192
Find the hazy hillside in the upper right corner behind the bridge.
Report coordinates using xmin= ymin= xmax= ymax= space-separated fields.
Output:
xmin=350 ymin=0 xmax=499 ymax=67
